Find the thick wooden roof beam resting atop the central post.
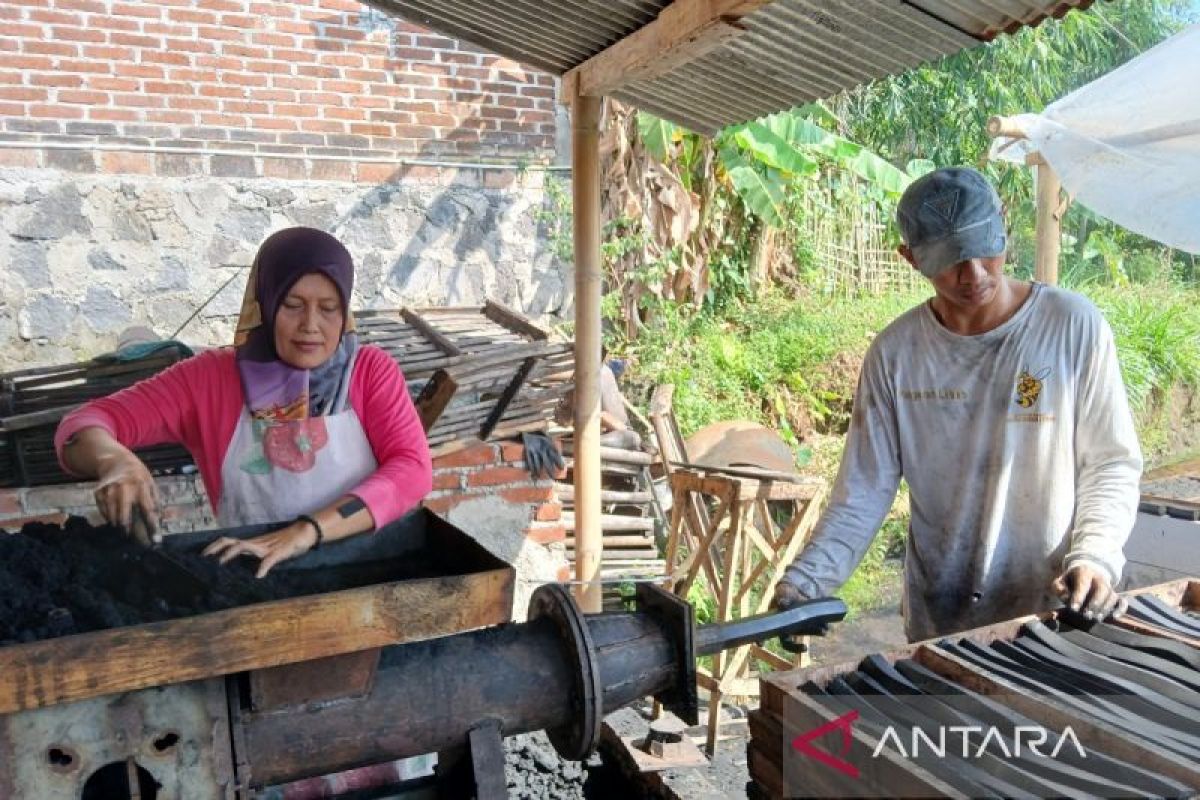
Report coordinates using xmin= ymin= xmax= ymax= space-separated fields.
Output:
xmin=563 ymin=0 xmax=772 ymax=103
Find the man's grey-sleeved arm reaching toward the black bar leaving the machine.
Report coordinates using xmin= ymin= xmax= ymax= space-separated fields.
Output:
xmin=776 ymin=345 xmax=900 ymax=599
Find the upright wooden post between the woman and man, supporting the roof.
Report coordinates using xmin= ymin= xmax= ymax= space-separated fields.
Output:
xmin=571 ymin=96 xmax=604 ymax=613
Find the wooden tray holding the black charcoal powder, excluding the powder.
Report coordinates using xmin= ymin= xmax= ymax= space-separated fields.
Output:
xmin=0 ymin=510 xmax=514 ymax=714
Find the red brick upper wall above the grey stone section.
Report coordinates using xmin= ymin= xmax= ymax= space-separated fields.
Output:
xmin=0 ymin=0 xmax=556 ymax=167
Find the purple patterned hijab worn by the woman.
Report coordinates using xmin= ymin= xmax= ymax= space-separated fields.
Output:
xmin=234 ymin=228 xmax=358 ymax=421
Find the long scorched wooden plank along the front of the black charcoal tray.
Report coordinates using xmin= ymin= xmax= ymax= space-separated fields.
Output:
xmin=0 ymin=569 xmax=512 ymax=714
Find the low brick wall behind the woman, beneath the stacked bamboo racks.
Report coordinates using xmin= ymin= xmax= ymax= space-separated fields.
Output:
xmin=0 ymin=443 xmax=571 ymax=619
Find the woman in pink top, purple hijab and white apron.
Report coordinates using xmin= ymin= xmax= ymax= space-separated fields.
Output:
xmin=55 ymin=228 xmax=432 ymax=577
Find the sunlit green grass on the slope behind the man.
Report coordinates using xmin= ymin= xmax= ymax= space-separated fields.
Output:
xmin=614 ymin=284 xmax=1200 ymax=616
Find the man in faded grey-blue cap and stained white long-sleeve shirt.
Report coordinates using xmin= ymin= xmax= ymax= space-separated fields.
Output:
xmin=775 ymin=168 xmax=1141 ymax=642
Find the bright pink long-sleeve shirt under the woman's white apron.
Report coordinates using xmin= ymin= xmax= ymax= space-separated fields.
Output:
xmin=54 ymin=345 xmax=433 ymax=528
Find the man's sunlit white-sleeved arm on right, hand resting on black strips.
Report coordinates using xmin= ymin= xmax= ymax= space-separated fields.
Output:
xmin=1061 ymin=319 xmax=1141 ymax=616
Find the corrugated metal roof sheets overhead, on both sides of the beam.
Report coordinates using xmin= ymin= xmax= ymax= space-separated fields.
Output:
xmin=370 ymin=0 xmax=1092 ymax=133
